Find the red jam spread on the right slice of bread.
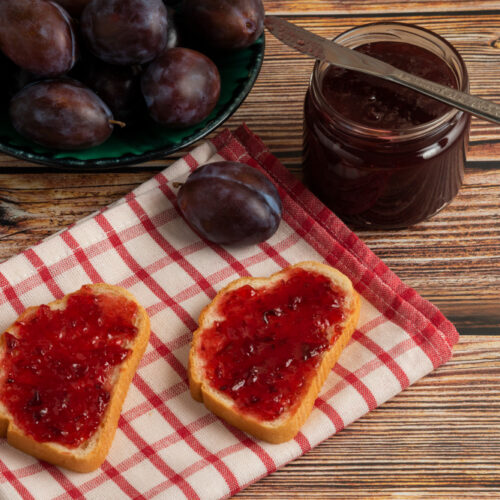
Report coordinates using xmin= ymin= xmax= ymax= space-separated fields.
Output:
xmin=200 ymin=269 xmax=345 ymax=421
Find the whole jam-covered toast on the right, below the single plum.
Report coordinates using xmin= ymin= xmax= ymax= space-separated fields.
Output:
xmin=188 ymin=262 xmax=360 ymax=443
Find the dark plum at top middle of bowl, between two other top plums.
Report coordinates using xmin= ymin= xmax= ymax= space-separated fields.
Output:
xmin=81 ymin=0 xmax=168 ymax=66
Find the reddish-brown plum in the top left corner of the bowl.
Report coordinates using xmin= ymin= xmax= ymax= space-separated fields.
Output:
xmin=0 ymin=0 xmax=78 ymax=76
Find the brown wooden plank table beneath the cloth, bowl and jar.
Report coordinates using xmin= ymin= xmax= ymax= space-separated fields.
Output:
xmin=0 ymin=0 xmax=500 ymax=499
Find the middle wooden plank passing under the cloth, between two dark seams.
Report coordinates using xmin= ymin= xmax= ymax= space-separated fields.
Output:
xmin=0 ymin=168 xmax=500 ymax=334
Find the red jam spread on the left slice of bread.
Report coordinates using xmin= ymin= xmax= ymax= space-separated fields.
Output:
xmin=0 ymin=287 xmax=137 ymax=447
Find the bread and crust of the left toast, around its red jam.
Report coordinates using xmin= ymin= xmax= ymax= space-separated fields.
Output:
xmin=0 ymin=283 xmax=150 ymax=472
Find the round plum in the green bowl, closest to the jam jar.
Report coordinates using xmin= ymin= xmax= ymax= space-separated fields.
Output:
xmin=141 ymin=47 xmax=220 ymax=128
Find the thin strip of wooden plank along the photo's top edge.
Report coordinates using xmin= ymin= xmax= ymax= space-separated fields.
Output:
xmin=264 ymin=0 xmax=500 ymax=16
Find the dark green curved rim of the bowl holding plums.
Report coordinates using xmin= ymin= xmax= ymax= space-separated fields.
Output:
xmin=0 ymin=32 xmax=266 ymax=170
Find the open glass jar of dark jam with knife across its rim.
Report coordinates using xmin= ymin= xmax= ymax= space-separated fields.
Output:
xmin=303 ymin=23 xmax=470 ymax=229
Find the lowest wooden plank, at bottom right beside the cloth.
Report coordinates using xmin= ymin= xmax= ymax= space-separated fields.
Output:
xmin=235 ymin=337 xmax=500 ymax=499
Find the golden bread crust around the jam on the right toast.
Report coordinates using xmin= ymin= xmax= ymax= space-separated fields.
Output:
xmin=188 ymin=261 xmax=361 ymax=443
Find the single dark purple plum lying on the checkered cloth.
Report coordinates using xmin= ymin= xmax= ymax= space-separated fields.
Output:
xmin=177 ymin=161 xmax=282 ymax=245
